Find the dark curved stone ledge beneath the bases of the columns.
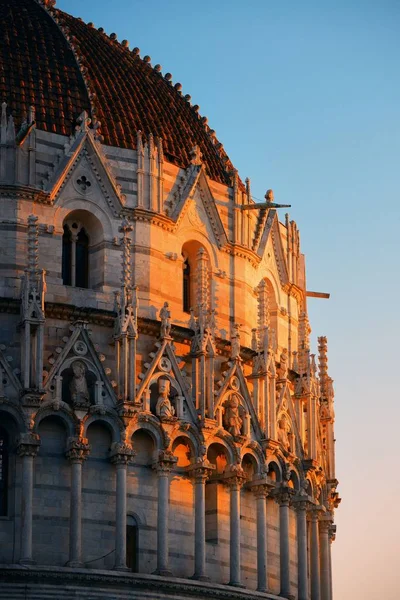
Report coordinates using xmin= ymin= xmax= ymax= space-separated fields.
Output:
xmin=0 ymin=565 xmax=284 ymax=600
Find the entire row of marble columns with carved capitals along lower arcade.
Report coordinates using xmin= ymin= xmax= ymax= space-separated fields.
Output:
xmin=18 ymin=434 xmax=334 ymax=600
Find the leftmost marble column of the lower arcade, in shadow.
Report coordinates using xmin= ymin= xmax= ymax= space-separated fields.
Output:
xmin=17 ymin=433 xmax=40 ymax=565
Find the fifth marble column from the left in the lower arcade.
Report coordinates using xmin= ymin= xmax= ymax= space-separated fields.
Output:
xmin=191 ymin=461 xmax=215 ymax=581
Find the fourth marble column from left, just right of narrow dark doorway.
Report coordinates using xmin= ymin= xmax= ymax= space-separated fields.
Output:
xmin=154 ymin=450 xmax=177 ymax=576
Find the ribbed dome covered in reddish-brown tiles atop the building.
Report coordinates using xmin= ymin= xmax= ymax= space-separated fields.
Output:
xmin=0 ymin=0 xmax=233 ymax=183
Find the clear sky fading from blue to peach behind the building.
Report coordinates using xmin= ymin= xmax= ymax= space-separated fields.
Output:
xmin=57 ymin=0 xmax=400 ymax=600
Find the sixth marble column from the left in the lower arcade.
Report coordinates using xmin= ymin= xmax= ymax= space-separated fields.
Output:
xmin=227 ymin=467 xmax=246 ymax=587
